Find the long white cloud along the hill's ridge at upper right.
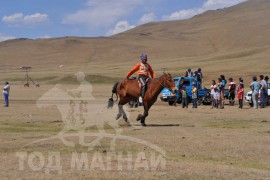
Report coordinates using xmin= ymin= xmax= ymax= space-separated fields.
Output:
xmin=162 ymin=0 xmax=246 ymax=20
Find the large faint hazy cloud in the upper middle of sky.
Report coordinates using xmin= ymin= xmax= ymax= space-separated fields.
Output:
xmin=62 ymin=0 xmax=144 ymax=28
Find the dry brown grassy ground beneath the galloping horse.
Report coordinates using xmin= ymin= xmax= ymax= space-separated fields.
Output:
xmin=0 ymin=84 xmax=270 ymax=179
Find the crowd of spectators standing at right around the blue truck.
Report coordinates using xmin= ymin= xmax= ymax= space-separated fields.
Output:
xmin=185 ymin=68 xmax=269 ymax=109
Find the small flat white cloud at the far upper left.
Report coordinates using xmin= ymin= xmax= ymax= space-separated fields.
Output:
xmin=2 ymin=13 xmax=49 ymax=25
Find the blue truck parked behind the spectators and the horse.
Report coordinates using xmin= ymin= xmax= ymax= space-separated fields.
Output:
xmin=160 ymin=76 xmax=211 ymax=105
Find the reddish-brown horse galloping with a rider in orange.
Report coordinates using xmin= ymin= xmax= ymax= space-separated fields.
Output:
xmin=108 ymin=73 xmax=176 ymax=126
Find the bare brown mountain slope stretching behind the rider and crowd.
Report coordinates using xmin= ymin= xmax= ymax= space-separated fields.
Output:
xmin=0 ymin=0 xmax=270 ymax=80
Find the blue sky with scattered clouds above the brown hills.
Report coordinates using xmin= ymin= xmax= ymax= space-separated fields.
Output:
xmin=0 ymin=0 xmax=245 ymax=41
